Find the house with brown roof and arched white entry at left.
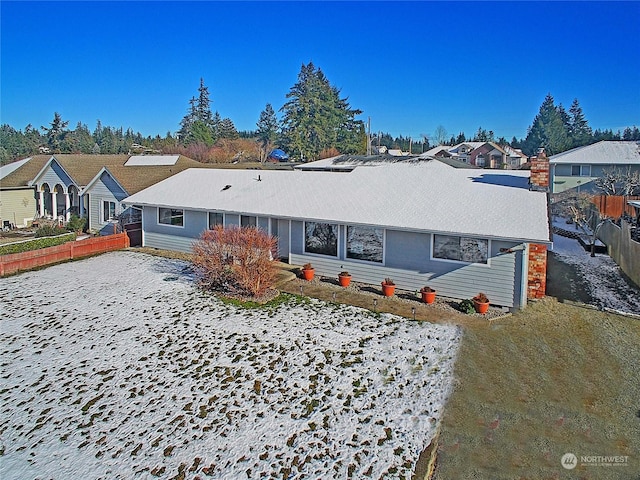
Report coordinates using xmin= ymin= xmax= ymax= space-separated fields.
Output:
xmin=2 ymin=154 xmax=203 ymax=231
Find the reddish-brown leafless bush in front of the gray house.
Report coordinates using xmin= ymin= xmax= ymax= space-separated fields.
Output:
xmin=193 ymin=225 xmax=276 ymax=298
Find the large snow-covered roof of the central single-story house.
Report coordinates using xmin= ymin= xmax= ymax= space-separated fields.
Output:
xmin=124 ymin=160 xmax=549 ymax=242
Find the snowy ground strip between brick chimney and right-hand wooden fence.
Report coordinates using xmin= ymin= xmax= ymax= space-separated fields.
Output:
xmin=553 ymin=219 xmax=640 ymax=314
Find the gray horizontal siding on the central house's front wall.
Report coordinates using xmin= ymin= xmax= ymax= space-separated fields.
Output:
xmin=143 ymin=207 xmax=527 ymax=308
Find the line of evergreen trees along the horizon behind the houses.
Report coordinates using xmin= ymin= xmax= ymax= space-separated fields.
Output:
xmin=0 ymin=62 xmax=640 ymax=165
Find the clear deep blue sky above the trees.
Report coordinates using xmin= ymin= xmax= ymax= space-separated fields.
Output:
xmin=0 ymin=0 xmax=640 ymax=139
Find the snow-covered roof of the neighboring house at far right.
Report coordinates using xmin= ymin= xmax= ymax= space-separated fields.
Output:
xmin=549 ymin=140 xmax=640 ymax=165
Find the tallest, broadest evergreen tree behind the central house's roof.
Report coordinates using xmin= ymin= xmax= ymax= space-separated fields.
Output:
xmin=281 ymin=62 xmax=366 ymax=160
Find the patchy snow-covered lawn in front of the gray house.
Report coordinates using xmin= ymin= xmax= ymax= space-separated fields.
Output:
xmin=0 ymin=252 xmax=460 ymax=479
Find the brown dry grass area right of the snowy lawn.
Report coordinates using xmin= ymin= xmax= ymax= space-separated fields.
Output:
xmin=434 ymin=298 xmax=640 ymax=480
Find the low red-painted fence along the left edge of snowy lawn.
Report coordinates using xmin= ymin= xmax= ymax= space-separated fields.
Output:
xmin=0 ymin=233 xmax=129 ymax=277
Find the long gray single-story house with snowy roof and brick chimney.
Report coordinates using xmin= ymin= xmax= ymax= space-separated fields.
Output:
xmin=123 ymin=160 xmax=550 ymax=308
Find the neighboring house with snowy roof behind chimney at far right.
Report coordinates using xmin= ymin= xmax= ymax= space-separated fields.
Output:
xmin=549 ymin=141 xmax=640 ymax=193
